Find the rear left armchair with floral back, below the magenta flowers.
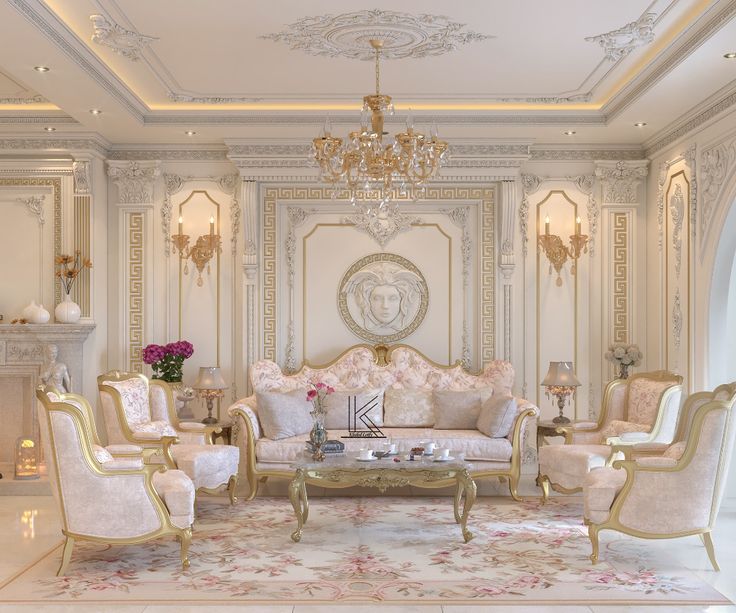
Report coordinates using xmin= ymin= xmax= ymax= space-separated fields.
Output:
xmin=97 ymin=371 xmax=240 ymax=504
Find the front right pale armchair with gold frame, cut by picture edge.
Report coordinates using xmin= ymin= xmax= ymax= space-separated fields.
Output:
xmin=583 ymin=386 xmax=736 ymax=570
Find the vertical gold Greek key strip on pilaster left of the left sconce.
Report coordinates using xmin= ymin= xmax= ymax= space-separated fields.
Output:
xmin=127 ymin=213 xmax=145 ymax=372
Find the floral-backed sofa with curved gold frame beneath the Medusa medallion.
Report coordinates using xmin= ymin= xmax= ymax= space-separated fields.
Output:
xmin=228 ymin=345 xmax=539 ymax=500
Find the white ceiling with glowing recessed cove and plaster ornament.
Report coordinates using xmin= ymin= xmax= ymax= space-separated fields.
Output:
xmin=0 ymin=0 xmax=736 ymax=145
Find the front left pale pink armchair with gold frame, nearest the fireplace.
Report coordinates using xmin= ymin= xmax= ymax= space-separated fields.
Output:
xmin=36 ymin=387 xmax=194 ymax=575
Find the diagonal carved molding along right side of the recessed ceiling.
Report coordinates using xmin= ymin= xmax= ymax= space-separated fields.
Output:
xmin=601 ymin=2 xmax=736 ymax=121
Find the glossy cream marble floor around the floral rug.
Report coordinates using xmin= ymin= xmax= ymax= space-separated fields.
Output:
xmin=0 ymin=480 xmax=736 ymax=613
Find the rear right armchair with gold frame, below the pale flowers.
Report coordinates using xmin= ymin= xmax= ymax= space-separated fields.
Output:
xmin=537 ymin=370 xmax=682 ymax=501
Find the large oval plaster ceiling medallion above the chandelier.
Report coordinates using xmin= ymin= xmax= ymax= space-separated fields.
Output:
xmin=261 ymin=10 xmax=494 ymax=60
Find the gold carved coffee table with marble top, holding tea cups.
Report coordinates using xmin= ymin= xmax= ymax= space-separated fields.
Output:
xmin=289 ymin=454 xmax=476 ymax=543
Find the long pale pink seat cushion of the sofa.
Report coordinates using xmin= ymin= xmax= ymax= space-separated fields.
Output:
xmin=256 ymin=428 xmax=511 ymax=463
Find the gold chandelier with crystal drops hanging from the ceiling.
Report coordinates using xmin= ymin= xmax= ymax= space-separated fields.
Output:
xmin=313 ymin=40 xmax=447 ymax=208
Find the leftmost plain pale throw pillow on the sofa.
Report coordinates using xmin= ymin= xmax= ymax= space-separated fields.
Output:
xmin=256 ymin=389 xmax=314 ymax=441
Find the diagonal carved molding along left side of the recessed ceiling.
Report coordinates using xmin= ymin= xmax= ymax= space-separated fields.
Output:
xmin=8 ymin=0 xmax=148 ymax=123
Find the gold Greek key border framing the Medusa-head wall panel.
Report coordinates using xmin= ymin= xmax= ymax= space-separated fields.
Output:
xmin=262 ymin=186 xmax=496 ymax=364
